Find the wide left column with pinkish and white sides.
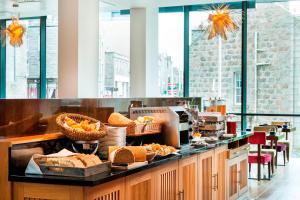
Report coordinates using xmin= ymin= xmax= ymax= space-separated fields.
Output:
xmin=58 ymin=0 xmax=99 ymax=98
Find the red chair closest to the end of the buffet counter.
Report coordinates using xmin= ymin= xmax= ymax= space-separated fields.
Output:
xmin=248 ymin=132 xmax=272 ymax=181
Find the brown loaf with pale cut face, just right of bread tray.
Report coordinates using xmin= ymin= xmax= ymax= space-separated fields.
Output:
xmin=109 ymin=148 xmax=134 ymax=164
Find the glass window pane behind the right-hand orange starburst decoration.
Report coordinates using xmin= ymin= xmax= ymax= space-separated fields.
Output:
xmin=189 ymin=10 xmax=241 ymax=113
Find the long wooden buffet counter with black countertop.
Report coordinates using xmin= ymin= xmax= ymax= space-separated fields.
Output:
xmin=0 ymin=132 xmax=251 ymax=200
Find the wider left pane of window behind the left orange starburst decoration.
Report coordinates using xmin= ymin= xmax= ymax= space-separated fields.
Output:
xmin=6 ymin=19 xmax=40 ymax=98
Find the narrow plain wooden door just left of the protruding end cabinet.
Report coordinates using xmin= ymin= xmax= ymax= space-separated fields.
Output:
xmin=213 ymin=146 xmax=228 ymax=200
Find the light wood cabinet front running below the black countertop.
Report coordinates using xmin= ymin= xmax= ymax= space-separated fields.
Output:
xmin=12 ymin=146 xmax=227 ymax=200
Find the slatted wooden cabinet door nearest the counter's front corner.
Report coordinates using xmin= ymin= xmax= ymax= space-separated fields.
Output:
xmin=84 ymin=178 xmax=125 ymax=200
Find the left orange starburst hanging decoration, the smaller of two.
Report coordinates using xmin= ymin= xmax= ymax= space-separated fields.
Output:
xmin=2 ymin=17 xmax=26 ymax=47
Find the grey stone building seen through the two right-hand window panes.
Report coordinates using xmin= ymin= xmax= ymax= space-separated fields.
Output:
xmin=190 ymin=3 xmax=300 ymax=148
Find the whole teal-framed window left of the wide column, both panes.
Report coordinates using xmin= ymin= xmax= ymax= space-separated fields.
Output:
xmin=0 ymin=16 xmax=58 ymax=99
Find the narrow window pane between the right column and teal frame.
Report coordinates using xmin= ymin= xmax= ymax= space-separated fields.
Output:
xmin=158 ymin=12 xmax=184 ymax=97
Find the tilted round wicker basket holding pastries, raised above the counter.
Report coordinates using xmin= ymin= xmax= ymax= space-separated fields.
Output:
xmin=56 ymin=113 xmax=106 ymax=141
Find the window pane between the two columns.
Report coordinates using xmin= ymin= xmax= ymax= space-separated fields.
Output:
xmin=98 ymin=11 xmax=130 ymax=97
